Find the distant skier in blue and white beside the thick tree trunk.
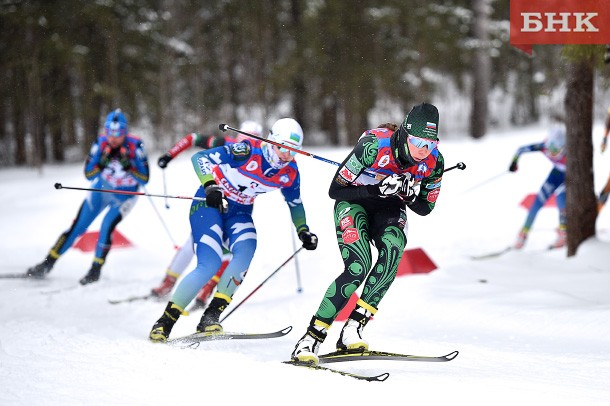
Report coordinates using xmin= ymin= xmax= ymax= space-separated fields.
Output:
xmin=508 ymin=126 xmax=567 ymax=249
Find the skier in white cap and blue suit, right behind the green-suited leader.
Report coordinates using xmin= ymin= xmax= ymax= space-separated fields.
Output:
xmin=149 ymin=118 xmax=318 ymax=342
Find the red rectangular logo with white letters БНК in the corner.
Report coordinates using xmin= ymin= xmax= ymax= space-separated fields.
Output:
xmin=510 ymin=0 xmax=610 ymax=55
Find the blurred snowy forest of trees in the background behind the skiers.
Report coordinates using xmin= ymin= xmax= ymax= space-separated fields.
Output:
xmin=0 ymin=0 xmax=609 ymax=166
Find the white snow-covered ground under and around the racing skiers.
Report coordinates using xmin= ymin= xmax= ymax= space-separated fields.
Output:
xmin=0 ymin=125 xmax=610 ymax=405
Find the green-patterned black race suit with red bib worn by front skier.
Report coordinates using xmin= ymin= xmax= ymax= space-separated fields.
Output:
xmin=315 ymin=128 xmax=444 ymax=328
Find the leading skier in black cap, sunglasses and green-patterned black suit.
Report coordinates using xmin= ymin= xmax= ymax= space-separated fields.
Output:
xmin=292 ymin=103 xmax=444 ymax=363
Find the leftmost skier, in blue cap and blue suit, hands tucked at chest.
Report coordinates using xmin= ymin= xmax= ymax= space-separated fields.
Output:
xmin=26 ymin=109 xmax=149 ymax=285
